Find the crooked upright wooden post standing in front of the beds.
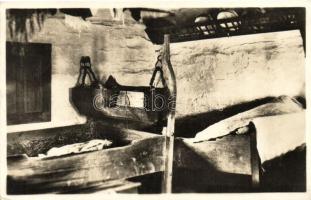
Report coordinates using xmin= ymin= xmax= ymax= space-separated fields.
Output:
xmin=162 ymin=34 xmax=177 ymax=193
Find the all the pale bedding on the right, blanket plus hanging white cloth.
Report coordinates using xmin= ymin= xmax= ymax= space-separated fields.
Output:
xmin=189 ymin=96 xmax=305 ymax=163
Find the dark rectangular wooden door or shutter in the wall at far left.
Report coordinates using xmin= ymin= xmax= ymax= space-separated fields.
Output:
xmin=6 ymin=42 xmax=51 ymax=125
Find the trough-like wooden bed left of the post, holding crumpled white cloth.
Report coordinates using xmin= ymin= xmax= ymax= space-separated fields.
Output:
xmin=8 ymin=124 xmax=165 ymax=193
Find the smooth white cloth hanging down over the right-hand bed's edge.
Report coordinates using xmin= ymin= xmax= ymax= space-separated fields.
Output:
xmin=253 ymin=111 xmax=306 ymax=163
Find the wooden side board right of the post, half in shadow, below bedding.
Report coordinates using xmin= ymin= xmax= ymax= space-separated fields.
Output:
xmin=174 ymin=134 xmax=252 ymax=175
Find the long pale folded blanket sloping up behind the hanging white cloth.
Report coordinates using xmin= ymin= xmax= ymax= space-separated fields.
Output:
xmin=192 ymin=96 xmax=303 ymax=142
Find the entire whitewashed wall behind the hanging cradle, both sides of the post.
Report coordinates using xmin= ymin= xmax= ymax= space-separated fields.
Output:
xmin=7 ymin=11 xmax=304 ymax=132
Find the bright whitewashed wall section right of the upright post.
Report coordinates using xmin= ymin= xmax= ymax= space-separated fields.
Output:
xmin=171 ymin=30 xmax=305 ymax=116
